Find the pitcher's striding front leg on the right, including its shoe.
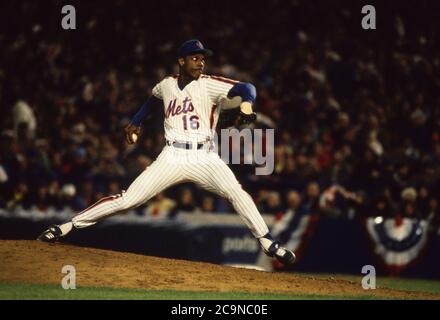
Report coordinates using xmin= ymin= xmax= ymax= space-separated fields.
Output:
xmin=184 ymin=150 xmax=295 ymax=264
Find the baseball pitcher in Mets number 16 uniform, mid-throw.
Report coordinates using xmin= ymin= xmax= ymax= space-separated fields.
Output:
xmin=38 ymin=40 xmax=295 ymax=264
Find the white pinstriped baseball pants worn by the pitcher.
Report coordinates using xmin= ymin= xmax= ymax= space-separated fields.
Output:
xmin=72 ymin=146 xmax=269 ymax=238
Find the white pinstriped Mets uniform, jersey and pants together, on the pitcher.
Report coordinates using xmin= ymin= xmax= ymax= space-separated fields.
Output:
xmin=72 ymin=75 xmax=269 ymax=238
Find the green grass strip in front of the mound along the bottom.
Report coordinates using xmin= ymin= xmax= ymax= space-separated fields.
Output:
xmin=0 ymin=283 xmax=394 ymax=300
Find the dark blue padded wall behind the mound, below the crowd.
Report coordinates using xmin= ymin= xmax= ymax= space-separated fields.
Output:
xmin=0 ymin=211 xmax=440 ymax=279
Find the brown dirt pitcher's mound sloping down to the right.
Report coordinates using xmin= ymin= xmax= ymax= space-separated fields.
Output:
xmin=0 ymin=241 xmax=440 ymax=299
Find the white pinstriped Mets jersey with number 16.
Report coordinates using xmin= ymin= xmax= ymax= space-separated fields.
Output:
xmin=152 ymin=75 xmax=238 ymax=142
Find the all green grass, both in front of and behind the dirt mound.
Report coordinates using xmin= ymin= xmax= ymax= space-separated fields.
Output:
xmin=0 ymin=274 xmax=440 ymax=300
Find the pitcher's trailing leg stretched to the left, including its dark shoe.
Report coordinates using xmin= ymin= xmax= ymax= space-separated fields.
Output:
xmin=37 ymin=147 xmax=182 ymax=242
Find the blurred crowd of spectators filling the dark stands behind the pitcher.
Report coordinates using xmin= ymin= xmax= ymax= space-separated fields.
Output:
xmin=0 ymin=0 xmax=440 ymax=225
